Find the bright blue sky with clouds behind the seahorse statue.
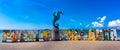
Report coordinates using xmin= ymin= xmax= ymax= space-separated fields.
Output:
xmin=0 ymin=0 xmax=120 ymax=29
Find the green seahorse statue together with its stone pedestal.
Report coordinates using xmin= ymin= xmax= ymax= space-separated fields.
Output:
xmin=52 ymin=11 xmax=63 ymax=41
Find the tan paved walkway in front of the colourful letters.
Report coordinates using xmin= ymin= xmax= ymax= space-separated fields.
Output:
xmin=0 ymin=41 xmax=120 ymax=50
